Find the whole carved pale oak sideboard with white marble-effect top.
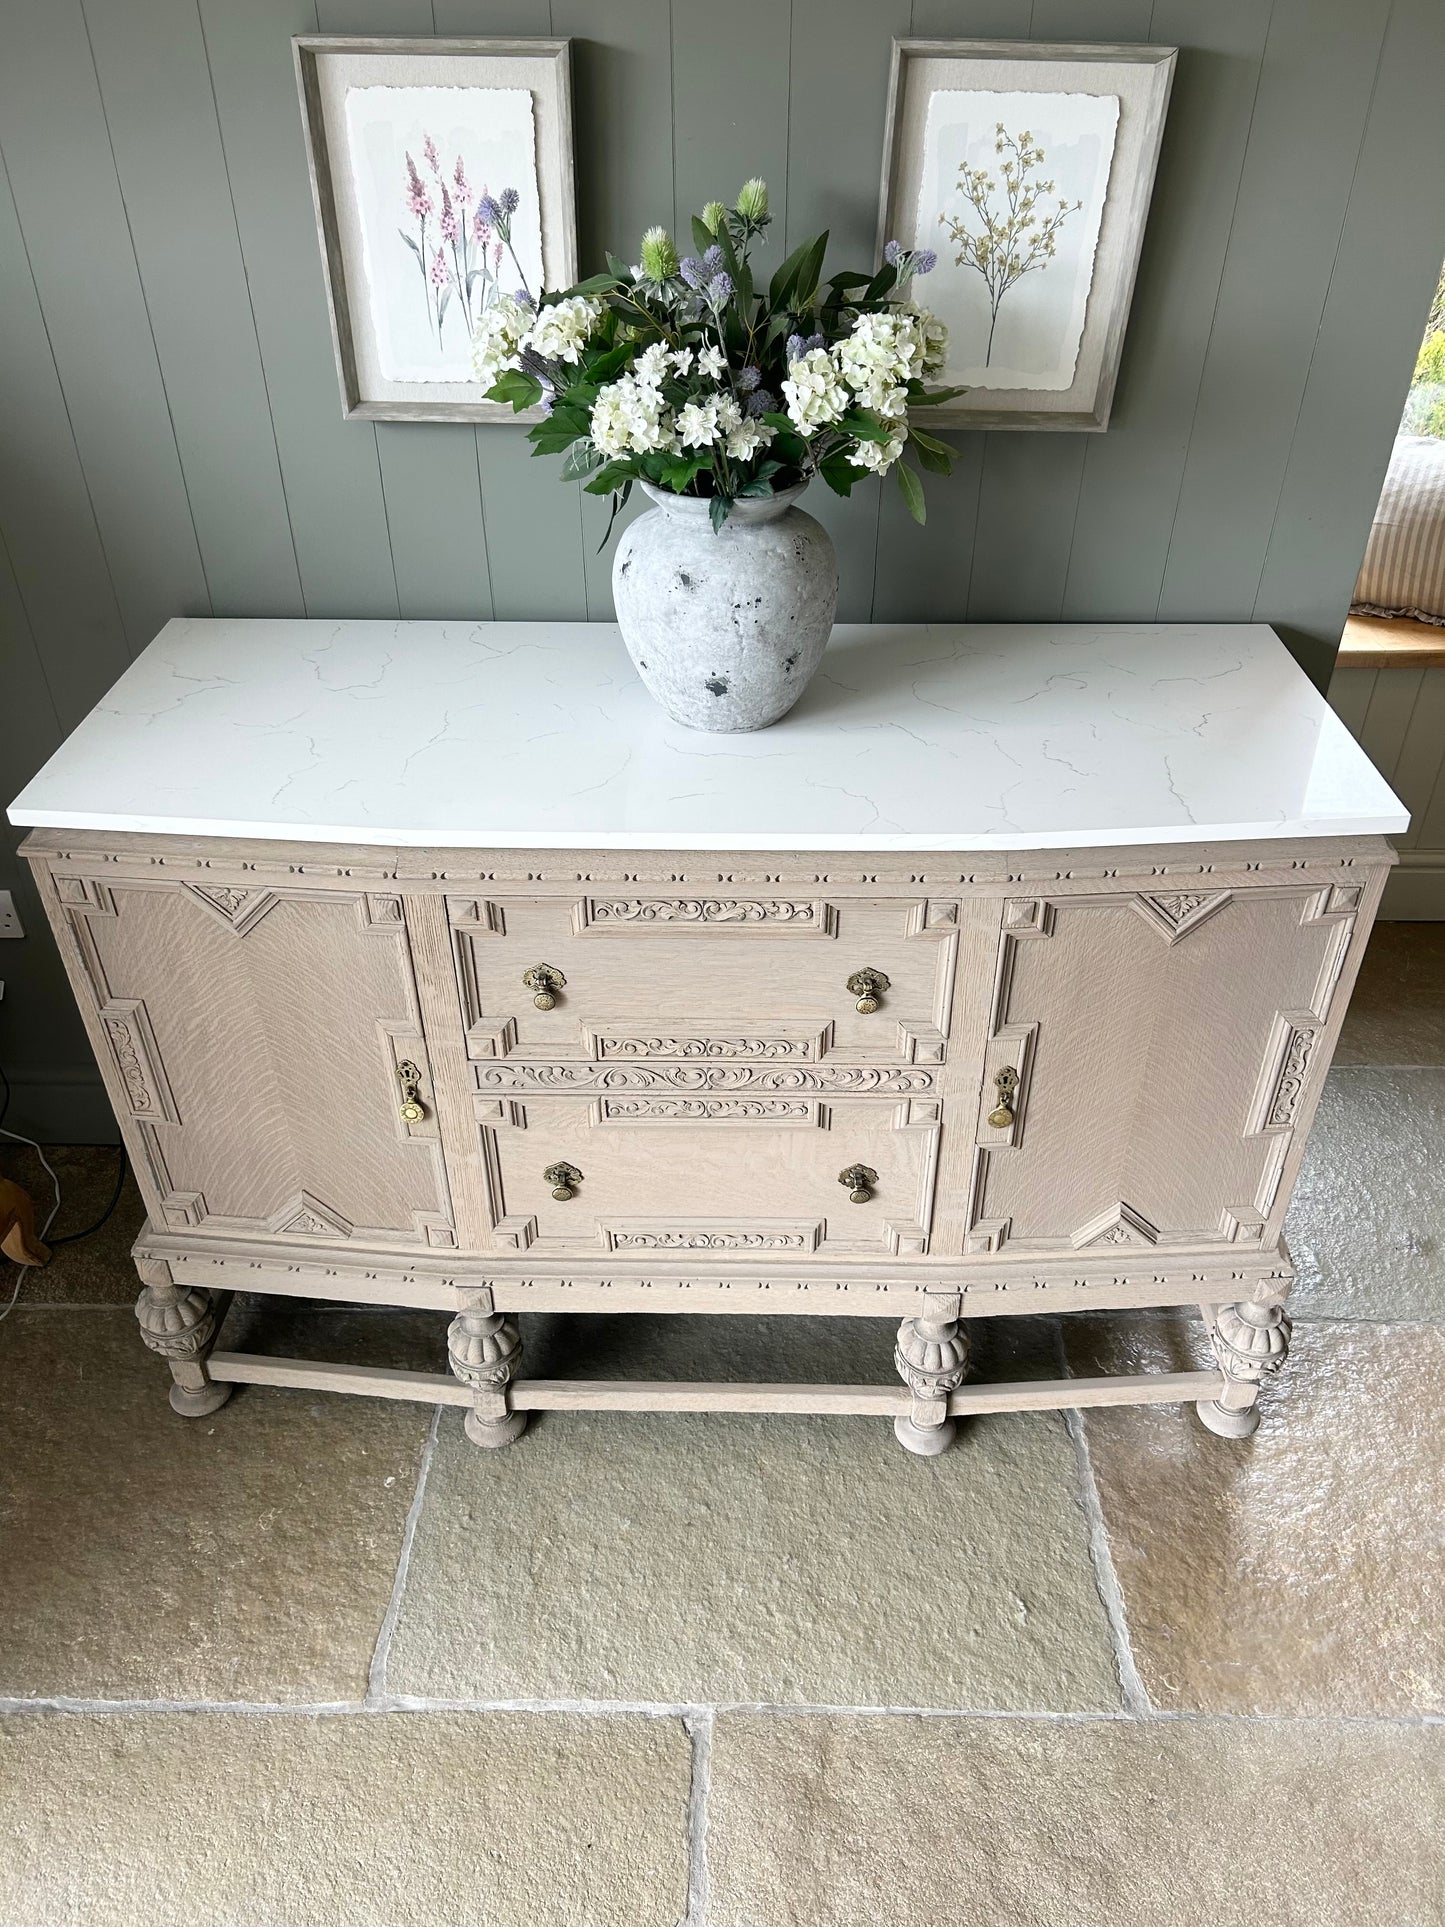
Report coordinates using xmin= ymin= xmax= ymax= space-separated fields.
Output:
xmin=12 ymin=620 xmax=1406 ymax=1453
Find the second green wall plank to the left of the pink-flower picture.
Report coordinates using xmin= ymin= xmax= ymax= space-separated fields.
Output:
xmin=87 ymin=0 xmax=304 ymax=612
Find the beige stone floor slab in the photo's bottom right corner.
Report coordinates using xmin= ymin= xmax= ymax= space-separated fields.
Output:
xmin=707 ymin=1715 xmax=1445 ymax=1927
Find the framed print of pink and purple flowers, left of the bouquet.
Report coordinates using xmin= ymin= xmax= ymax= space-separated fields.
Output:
xmin=291 ymin=35 xmax=578 ymax=422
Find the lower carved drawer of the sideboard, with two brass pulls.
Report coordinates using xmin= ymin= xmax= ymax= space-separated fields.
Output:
xmin=478 ymin=1093 xmax=940 ymax=1256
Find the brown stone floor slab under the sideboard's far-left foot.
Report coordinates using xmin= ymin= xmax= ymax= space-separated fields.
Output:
xmin=0 ymin=1305 xmax=445 ymax=1703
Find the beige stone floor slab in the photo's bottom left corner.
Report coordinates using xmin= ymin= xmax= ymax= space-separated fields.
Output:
xmin=0 ymin=1713 xmax=692 ymax=1927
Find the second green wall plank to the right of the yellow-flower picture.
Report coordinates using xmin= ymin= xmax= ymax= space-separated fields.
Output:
xmin=1160 ymin=0 xmax=1389 ymax=620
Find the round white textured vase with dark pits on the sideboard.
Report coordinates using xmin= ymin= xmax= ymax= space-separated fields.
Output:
xmin=613 ymin=482 xmax=838 ymax=730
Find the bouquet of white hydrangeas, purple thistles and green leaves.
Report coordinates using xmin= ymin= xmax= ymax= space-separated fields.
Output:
xmin=472 ymin=181 xmax=961 ymax=541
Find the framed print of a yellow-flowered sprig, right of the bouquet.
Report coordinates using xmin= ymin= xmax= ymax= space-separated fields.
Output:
xmin=879 ymin=39 xmax=1177 ymax=430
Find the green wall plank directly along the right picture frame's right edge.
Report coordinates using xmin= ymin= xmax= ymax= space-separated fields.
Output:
xmin=1062 ymin=0 xmax=1270 ymax=622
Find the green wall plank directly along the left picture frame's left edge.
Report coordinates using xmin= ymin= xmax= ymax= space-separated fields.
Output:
xmin=200 ymin=0 xmax=397 ymax=617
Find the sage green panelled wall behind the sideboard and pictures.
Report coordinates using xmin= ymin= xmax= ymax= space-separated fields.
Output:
xmin=0 ymin=0 xmax=1445 ymax=1137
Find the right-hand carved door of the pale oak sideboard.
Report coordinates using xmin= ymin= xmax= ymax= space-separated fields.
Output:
xmin=967 ymin=888 xmax=1360 ymax=1251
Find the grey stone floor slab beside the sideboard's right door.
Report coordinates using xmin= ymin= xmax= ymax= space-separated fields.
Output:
xmin=1285 ymin=1068 xmax=1445 ymax=1322
